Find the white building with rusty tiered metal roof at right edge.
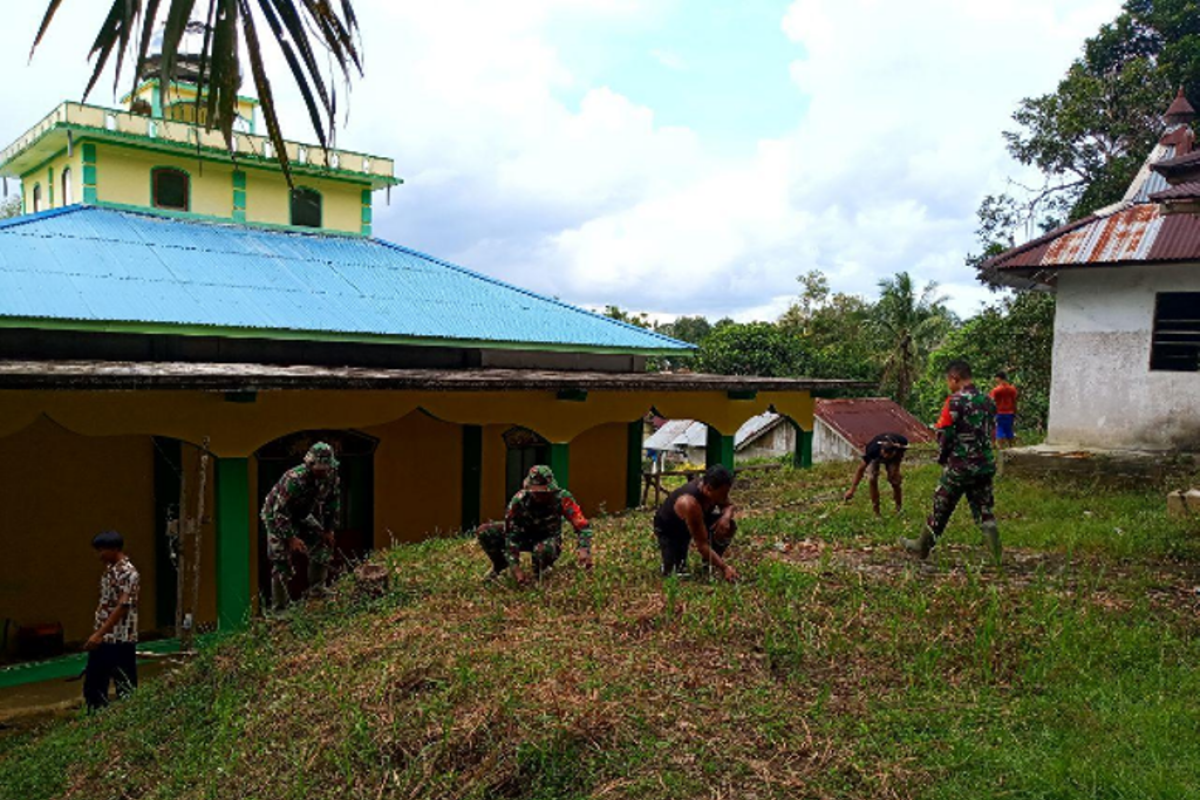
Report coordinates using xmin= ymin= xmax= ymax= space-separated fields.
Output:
xmin=983 ymin=90 xmax=1200 ymax=452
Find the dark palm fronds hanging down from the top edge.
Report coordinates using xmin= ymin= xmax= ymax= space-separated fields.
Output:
xmin=30 ymin=0 xmax=362 ymax=182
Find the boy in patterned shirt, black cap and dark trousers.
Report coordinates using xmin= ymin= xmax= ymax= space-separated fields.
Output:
xmin=83 ymin=530 xmax=140 ymax=711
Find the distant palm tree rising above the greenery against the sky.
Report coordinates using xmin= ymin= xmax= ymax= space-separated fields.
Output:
xmin=875 ymin=272 xmax=954 ymax=405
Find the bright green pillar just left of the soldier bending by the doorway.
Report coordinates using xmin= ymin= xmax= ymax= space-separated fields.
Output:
xmin=216 ymin=458 xmax=251 ymax=632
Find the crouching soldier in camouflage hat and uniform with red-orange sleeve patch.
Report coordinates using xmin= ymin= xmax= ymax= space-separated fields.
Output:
xmin=475 ymin=467 xmax=592 ymax=584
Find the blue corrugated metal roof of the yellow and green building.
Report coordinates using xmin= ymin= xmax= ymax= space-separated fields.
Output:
xmin=0 ymin=205 xmax=691 ymax=353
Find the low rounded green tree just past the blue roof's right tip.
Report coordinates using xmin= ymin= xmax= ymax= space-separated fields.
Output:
xmin=696 ymin=323 xmax=809 ymax=378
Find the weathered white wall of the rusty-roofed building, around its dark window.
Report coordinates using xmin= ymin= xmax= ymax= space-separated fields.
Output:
xmin=1046 ymin=265 xmax=1200 ymax=450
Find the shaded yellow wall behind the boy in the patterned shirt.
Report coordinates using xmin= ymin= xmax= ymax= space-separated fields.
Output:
xmin=0 ymin=420 xmax=155 ymax=640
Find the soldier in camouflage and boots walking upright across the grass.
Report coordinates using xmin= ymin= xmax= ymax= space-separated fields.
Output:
xmin=902 ymin=361 xmax=1001 ymax=564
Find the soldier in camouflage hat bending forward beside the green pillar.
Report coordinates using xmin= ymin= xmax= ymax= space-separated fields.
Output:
xmin=262 ymin=441 xmax=342 ymax=610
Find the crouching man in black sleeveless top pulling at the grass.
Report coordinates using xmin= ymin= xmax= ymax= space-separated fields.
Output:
xmin=654 ymin=464 xmax=738 ymax=581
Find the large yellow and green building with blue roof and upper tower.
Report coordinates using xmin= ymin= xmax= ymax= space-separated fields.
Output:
xmin=0 ymin=26 xmax=854 ymax=686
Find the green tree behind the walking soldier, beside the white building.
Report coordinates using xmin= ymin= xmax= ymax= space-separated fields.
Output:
xmin=914 ymin=291 xmax=1055 ymax=432
